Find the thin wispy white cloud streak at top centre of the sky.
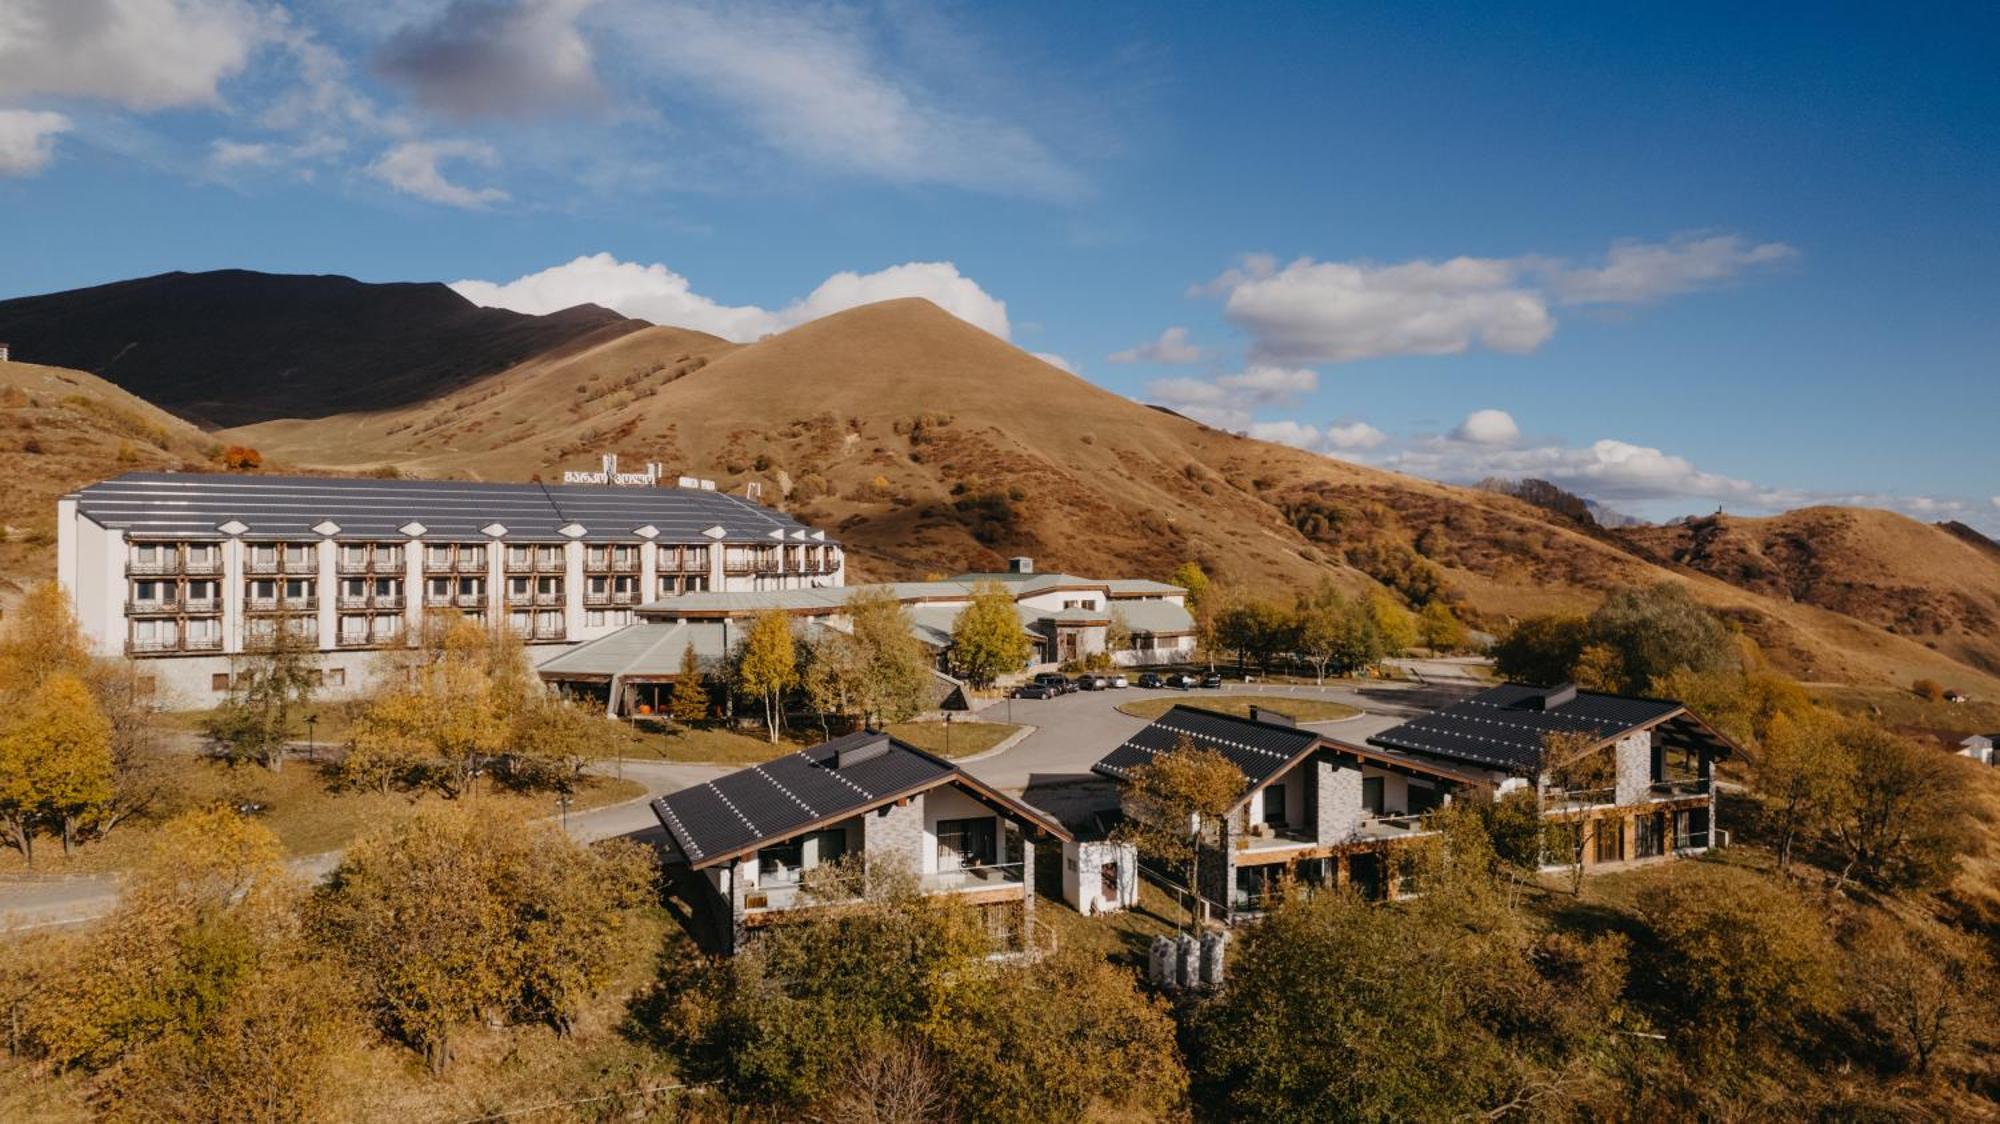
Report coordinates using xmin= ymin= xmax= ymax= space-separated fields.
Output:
xmin=602 ymin=0 xmax=1084 ymax=196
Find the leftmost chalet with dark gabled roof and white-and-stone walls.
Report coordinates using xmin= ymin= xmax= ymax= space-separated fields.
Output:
xmin=652 ymin=732 xmax=1072 ymax=952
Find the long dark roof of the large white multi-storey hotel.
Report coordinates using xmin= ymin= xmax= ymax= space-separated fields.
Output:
xmin=74 ymin=472 xmax=812 ymax=542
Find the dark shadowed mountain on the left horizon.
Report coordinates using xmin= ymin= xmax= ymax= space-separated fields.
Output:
xmin=0 ymin=270 xmax=644 ymax=426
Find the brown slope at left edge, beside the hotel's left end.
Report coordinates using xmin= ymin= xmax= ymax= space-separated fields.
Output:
xmin=0 ymin=362 xmax=220 ymax=608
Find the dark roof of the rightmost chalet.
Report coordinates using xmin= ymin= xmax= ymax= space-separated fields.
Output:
xmin=1368 ymin=684 xmax=1698 ymax=772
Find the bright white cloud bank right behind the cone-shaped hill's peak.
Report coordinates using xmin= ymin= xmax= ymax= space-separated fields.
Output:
xmin=452 ymin=254 xmax=1016 ymax=340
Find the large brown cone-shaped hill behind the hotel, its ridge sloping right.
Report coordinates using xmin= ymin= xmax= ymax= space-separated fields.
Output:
xmin=222 ymin=300 xmax=2000 ymax=694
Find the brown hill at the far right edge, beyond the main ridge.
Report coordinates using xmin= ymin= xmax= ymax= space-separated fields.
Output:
xmin=1620 ymin=508 xmax=2000 ymax=674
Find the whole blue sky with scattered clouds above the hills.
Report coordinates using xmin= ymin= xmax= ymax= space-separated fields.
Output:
xmin=0 ymin=0 xmax=2000 ymax=532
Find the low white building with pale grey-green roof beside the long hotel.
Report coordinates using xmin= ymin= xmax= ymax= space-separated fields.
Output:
xmin=538 ymin=558 xmax=1194 ymax=716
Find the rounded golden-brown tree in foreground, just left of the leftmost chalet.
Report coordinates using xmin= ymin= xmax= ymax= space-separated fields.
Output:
xmin=312 ymin=806 xmax=648 ymax=1072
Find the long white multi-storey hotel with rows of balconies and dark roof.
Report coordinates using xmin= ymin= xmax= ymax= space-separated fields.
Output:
xmin=56 ymin=472 xmax=846 ymax=704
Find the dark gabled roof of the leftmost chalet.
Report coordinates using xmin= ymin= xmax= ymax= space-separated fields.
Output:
xmin=652 ymin=732 xmax=1070 ymax=868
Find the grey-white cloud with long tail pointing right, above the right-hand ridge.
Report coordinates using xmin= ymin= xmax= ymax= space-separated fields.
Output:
xmin=1192 ymin=234 xmax=1798 ymax=366
